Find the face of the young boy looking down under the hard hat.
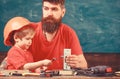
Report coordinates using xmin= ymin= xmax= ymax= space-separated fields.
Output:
xmin=15 ymin=33 xmax=34 ymax=50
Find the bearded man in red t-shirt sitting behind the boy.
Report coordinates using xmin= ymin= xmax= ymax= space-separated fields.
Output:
xmin=30 ymin=0 xmax=87 ymax=70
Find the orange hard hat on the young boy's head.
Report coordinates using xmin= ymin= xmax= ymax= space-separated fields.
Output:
xmin=4 ymin=16 xmax=36 ymax=46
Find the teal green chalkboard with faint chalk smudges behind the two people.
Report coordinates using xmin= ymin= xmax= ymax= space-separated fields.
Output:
xmin=0 ymin=0 xmax=120 ymax=53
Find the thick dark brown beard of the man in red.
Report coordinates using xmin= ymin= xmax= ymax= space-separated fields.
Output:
xmin=42 ymin=16 xmax=62 ymax=33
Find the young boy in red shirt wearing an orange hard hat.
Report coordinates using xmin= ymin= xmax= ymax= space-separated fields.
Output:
xmin=4 ymin=17 xmax=51 ymax=71
